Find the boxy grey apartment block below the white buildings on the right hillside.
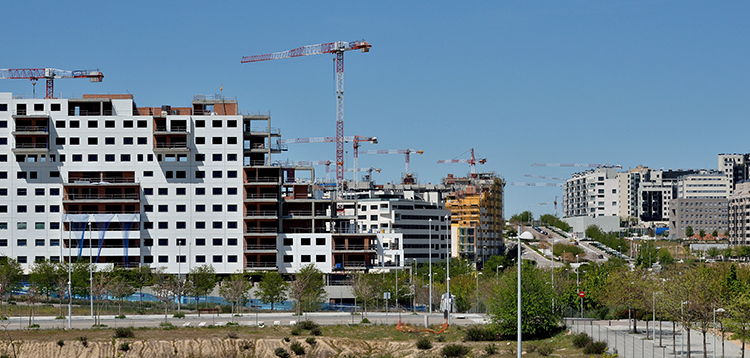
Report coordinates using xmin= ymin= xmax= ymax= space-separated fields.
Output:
xmin=669 ymin=197 xmax=729 ymax=238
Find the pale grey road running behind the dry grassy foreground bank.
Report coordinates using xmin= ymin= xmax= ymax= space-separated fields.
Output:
xmin=1 ymin=312 xmax=486 ymax=330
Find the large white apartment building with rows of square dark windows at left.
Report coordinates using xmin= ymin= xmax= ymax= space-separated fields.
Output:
xmin=0 ymin=93 xmax=250 ymax=273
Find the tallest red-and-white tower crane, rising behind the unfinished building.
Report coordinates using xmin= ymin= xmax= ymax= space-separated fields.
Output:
xmin=240 ymin=40 xmax=372 ymax=183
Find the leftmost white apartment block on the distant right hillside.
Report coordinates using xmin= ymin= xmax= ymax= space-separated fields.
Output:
xmin=563 ymin=167 xmax=620 ymax=218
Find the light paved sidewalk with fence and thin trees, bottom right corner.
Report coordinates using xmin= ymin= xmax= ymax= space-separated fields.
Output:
xmin=565 ymin=318 xmax=750 ymax=358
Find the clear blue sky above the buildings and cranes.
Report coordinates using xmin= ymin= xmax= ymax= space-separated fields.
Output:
xmin=0 ymin=0 xmax=750 ymax=214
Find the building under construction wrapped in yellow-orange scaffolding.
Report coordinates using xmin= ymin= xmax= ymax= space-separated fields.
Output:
xmin=443 ymin=173 xmax=505 ymax=266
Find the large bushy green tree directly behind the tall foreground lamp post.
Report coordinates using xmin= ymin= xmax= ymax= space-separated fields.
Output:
xmin=488 ymin=263 xmax=561 ymax=339
